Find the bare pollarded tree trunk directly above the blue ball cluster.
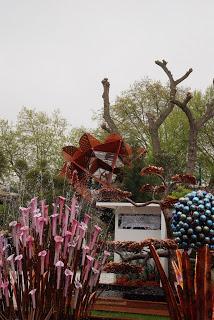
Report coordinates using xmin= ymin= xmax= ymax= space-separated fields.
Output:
xmin=172 ymin=92 xmax=214 ymax=174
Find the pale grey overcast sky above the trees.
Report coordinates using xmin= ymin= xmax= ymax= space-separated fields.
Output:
xmin=0 ymin=0 xmax=214 ymax=127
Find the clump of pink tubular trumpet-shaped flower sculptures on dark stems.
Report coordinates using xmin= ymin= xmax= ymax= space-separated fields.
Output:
xmin=0 ymin=197 xmax=109 ymax=320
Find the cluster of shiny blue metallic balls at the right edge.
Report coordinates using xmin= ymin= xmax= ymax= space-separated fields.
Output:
xmin=171 ymin=190 xmax=214 ymax=250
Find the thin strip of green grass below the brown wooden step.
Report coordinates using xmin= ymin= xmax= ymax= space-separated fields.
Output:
xmin=92 ymin=311 xmax=170 ymax=320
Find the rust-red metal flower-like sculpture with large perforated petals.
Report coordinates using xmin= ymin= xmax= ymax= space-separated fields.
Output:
xmin=61 ymin=133 xmax=132 ymax=187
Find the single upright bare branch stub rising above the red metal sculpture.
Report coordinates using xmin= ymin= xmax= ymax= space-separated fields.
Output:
xmin=102 ymin=78 xmax=118 ymax=133
